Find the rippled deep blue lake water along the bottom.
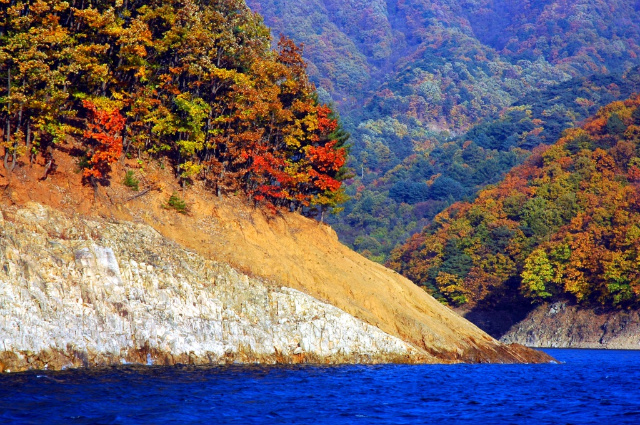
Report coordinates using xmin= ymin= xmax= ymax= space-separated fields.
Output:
xmin=0 ymin=349 xmax=640 ymax=425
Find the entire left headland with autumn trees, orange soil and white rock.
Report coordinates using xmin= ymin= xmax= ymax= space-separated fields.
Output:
xmin=0 ymin=0 xmax=551 ymax=366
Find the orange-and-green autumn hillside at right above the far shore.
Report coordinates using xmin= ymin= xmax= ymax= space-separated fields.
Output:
xmin=389 ymin=96 xmax=640 ymax=308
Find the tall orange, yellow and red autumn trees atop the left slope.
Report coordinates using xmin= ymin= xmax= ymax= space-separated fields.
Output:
xmin=0 ymin=0 xmax=347 ymax=209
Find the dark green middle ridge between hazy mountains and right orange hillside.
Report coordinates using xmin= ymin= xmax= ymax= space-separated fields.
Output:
xmin=332 ymin=68 xmax=640 ymax=261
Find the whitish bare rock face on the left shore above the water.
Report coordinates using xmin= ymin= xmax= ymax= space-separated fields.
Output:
xmin=0 ymin=204 xmax=417 ymax=369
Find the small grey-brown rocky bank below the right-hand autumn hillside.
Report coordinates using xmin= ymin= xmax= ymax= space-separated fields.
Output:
xmin=500 ymin=302 xmax=640 ymax=350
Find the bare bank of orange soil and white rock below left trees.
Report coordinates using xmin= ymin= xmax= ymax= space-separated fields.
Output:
xmin=0 ymin=153 xmax=549 ymax=370
